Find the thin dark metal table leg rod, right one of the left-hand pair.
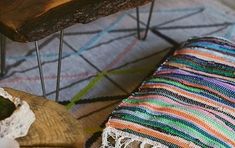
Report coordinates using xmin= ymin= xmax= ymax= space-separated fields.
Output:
xmin=55 ymin=30 xmax=64 ymax=102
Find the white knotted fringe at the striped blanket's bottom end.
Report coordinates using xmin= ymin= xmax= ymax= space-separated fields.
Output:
xmin=101 ymin=127 xmax=167 ymax=148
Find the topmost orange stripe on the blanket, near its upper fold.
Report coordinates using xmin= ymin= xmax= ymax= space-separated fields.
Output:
xmin=174 ymin=48 xmax=234 ymax=67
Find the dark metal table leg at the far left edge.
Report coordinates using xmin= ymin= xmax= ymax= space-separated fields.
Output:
xmin=0 ymin=34 xmax=6 ymax=77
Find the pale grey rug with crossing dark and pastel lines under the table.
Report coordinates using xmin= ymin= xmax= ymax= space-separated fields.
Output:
xmin=0 ymin=0 xmax=235 ymax=148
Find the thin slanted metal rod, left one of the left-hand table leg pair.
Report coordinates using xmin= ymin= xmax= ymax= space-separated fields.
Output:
xmin=35 ymin=41 xmax=46 ymax=97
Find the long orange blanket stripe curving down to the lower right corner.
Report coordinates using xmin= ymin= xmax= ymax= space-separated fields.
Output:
xmin=121 ymin=102 xmax=235 ymax=147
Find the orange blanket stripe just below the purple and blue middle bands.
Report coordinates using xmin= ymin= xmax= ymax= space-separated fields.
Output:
xmin=140 ymin=84 xmax=235 ymax=114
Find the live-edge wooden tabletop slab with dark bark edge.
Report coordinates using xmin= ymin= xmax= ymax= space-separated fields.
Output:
xmin=0 ymin=0 xmax=151 ymax=42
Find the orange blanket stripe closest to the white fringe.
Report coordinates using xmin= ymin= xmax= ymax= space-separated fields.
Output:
xmin=107 ymin=119 xmax=193 ymax=147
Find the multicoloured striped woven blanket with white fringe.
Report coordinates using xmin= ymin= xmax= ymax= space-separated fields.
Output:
xmin=102 ymin=37 xmax=235 ymax=148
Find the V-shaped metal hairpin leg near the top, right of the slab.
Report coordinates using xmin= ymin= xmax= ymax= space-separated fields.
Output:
xmin=136 ymin=0 xmax=155 ymax=41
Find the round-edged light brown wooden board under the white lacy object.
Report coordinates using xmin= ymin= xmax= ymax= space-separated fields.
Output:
xmin=4 ymin=88 xmax=85 ymax=148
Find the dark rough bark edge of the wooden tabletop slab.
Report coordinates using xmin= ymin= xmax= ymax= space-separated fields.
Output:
xmin=0 ymin=0 xmax=152 ymax=42
